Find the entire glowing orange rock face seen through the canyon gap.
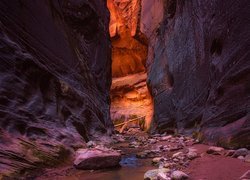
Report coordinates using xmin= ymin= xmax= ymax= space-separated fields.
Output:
xmin=107 ymin=0 xmax=152 ymax=128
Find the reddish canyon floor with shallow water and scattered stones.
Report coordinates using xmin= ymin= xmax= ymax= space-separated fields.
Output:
xmin=36 ymin=130 xmax=250 ymax=180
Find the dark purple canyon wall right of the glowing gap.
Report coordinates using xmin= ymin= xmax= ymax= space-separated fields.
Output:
xmin=141 ymin=0 xmax=250 ymax=147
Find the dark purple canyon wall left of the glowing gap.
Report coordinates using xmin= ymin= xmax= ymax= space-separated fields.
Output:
xmin=0 ymin=0 xmax=112 ymax=179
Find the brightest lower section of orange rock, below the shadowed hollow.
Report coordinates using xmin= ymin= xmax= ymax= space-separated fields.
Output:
xmin=110 ymin=73 xmax=153 ymax=130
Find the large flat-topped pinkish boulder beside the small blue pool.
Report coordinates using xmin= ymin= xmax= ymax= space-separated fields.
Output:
xmin=74 ymin=148 xmax=121 ymax=169
